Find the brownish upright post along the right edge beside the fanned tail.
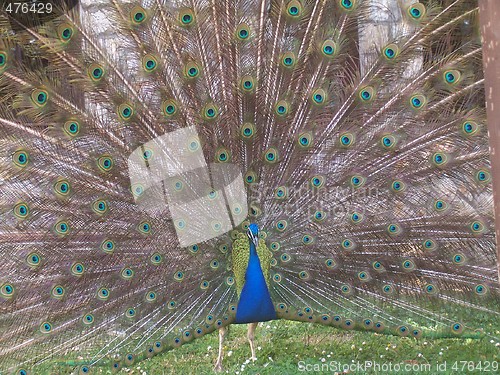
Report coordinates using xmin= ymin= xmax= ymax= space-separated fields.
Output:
xmin=479 ymin=0 xmax=500 ymax=282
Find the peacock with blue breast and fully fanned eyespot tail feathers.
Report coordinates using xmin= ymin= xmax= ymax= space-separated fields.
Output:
xmin=0 ymin=0 xmax=500 ymax=375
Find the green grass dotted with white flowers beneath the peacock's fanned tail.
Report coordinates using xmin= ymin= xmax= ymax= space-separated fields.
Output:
xmin=41 ymin=321 xmax=500 ymax=375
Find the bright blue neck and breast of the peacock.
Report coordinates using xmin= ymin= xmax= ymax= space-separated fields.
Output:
xmin=234 ymin=241 xmax=276 ymax=323
